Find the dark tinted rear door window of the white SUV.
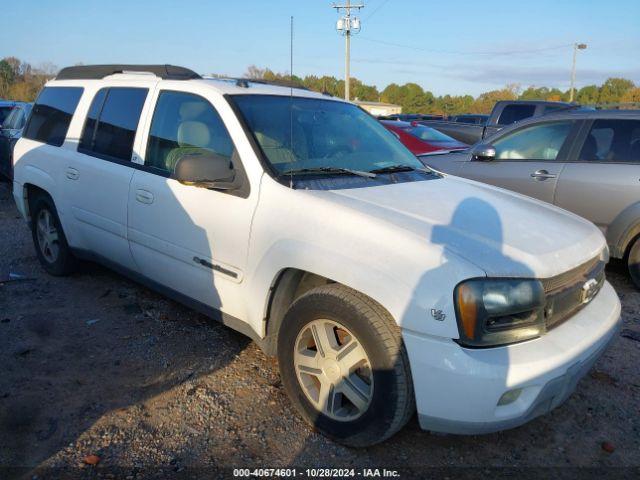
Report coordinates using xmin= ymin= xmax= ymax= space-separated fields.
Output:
xmin=78 ymin=87 xmax=148 ymax=161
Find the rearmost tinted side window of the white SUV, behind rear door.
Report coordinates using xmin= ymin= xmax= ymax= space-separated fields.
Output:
xmin=23 ymin=87 xmax=83 ymax=147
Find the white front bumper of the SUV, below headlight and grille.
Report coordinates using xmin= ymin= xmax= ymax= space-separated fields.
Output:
xmin=403 ymin=282 xmax=620 ymax=434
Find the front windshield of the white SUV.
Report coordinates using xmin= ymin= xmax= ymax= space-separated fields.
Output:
xmin=234 ymin=95 xmax=422 ymax=174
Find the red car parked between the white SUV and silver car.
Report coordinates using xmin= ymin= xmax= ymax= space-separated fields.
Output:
xmin=380 ymin=120 xmax=468 ymax=155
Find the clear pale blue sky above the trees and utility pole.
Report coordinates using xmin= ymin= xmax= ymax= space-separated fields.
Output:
xmin=0 ymin=0 xmax=640 ymax=96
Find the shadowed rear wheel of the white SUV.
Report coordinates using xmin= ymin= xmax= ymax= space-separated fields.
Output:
xmin=30 ymin=194 xmax=76 ymax=275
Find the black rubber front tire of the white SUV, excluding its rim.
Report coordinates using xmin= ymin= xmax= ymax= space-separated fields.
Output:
xmin=278 ymin=284 xmax=415 ymax=447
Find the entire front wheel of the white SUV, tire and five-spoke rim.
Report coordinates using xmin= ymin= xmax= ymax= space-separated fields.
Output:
xmin=278 ymin=284 xmax=415 ymax=446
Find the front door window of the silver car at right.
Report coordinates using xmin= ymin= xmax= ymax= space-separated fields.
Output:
xmin=493 ymin=121 xmax=573 ymax=161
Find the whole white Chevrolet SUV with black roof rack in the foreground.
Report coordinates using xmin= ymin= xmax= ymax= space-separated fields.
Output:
xmin=13 ymin=65 xmax=620 ymax=446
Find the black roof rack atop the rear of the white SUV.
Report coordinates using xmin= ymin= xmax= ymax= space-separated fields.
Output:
xmin=56 ymin=64 xmax=202 ymax=80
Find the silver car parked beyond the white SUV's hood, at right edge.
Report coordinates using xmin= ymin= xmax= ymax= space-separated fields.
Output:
xmin=421 ymin=110 xmax=640 ymax=287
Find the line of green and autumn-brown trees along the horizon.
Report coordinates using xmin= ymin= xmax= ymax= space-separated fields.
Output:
xmin=0 ymin=57 xmax=640 ymax=115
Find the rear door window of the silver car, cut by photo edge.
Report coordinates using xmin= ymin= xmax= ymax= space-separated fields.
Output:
xmin=579 ymin=119 xmax=640 ymax=163
